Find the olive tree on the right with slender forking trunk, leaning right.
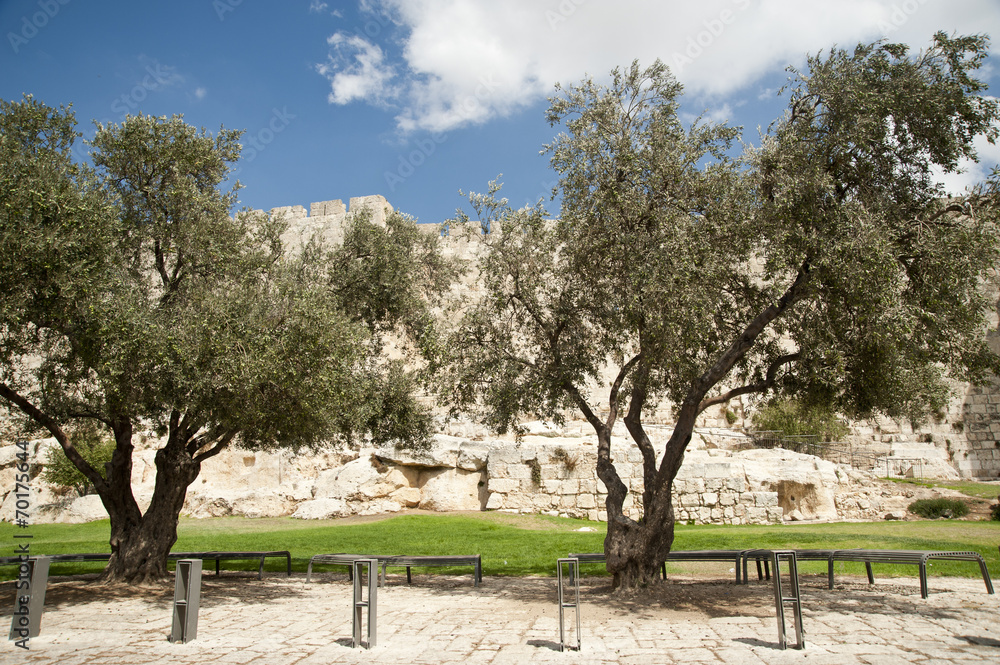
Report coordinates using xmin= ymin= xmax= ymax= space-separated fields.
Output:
xmin=444 ymin=34 xmax=1000 ymax=588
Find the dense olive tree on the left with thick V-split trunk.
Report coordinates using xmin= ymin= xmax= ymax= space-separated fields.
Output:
xmin=0 ymin=98 xmax=449 ymax=583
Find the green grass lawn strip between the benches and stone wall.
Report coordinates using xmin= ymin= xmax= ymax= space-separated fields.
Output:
xmin=0 ymin=512 xmax=1000 ymax=579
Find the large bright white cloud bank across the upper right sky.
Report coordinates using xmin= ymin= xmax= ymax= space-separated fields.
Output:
xmin=320 ymin=0 xmax=1000 ymax=131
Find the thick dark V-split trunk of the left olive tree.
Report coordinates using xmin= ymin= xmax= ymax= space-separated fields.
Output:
xmin=101 ymin=432 xmax=201 ymax=584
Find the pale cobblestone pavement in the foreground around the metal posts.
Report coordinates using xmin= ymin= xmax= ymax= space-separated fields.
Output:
xmin=0 ymin=574 xmax=1000 ymax=665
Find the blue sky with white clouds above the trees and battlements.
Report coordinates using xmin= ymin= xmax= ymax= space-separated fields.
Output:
xmin=0 ymin=0 xmax=1000 ymax=222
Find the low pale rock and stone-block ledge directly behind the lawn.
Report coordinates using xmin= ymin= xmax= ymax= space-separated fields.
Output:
xmin=0 ymin=426 xmax=906 ymax=524
